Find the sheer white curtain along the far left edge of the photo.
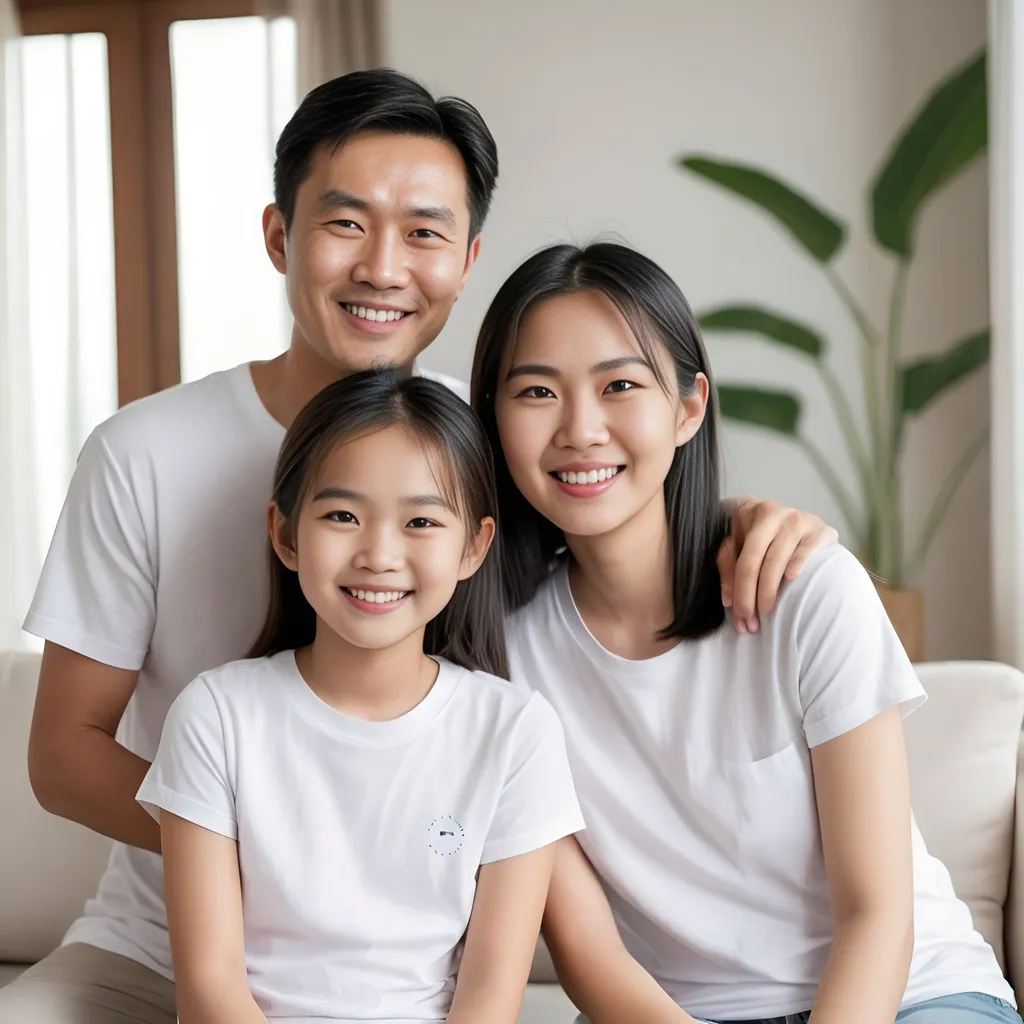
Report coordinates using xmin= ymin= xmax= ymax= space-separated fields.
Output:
xmin=0 ymin=0 xmax=40 ymax=648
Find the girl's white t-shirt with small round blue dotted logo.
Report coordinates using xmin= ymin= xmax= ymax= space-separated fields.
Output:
xmin=139 ymin=651 xmax=584 ymax=1024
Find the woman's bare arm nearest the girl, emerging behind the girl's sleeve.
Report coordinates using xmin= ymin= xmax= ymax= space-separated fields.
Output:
xmin=544 ymin=836 xmax=693 ymax=1024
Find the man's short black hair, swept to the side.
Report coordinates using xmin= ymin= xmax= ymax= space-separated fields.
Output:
xmin=273 ymin=68 xmax=498 ymax=241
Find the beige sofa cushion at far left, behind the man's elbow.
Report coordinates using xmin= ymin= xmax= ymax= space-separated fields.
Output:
xmin=0 ymin=651 xmax=111 ymax=963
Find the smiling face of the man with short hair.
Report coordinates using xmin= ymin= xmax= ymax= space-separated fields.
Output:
xmin=263 ymin=132 xmax=479 ymax=375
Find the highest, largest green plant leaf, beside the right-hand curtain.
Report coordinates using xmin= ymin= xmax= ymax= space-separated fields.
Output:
xmin=871 ymin=53 xmax=988 ymax=256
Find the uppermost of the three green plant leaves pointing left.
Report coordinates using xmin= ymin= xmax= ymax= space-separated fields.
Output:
xmin=678 ymin=155 xmax=846 ymax=263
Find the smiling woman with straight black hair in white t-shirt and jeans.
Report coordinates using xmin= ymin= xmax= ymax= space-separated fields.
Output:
xmin=473 ymin=244 xmax=1020 ymax=1024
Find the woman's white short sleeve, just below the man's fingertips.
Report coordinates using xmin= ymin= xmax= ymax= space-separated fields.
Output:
xmin=792 ymin=546 xmax=925 ymax=746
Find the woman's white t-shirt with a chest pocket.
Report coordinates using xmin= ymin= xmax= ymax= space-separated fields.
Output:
xmin=510 ymin=547 xmax=1014 ymax=1020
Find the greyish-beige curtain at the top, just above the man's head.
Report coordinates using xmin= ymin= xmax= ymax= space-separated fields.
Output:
xmin=256 ymin=0 xmax=383 ymax=96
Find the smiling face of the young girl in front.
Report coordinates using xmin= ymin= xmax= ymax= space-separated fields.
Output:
xmin=272 ymin=426 xmax=495 ymax=649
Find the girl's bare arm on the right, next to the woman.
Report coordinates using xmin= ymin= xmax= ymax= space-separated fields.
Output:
xmin=446 ymin=844 xmax=555 ymax=1024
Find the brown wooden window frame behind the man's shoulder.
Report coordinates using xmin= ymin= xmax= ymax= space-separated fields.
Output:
xmin=19 ymin=0 xmax=254 ymax=406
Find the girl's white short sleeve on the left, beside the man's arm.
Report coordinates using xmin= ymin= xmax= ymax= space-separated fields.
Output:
xmin=136 ymin=676 xmax=238 ymax=839
